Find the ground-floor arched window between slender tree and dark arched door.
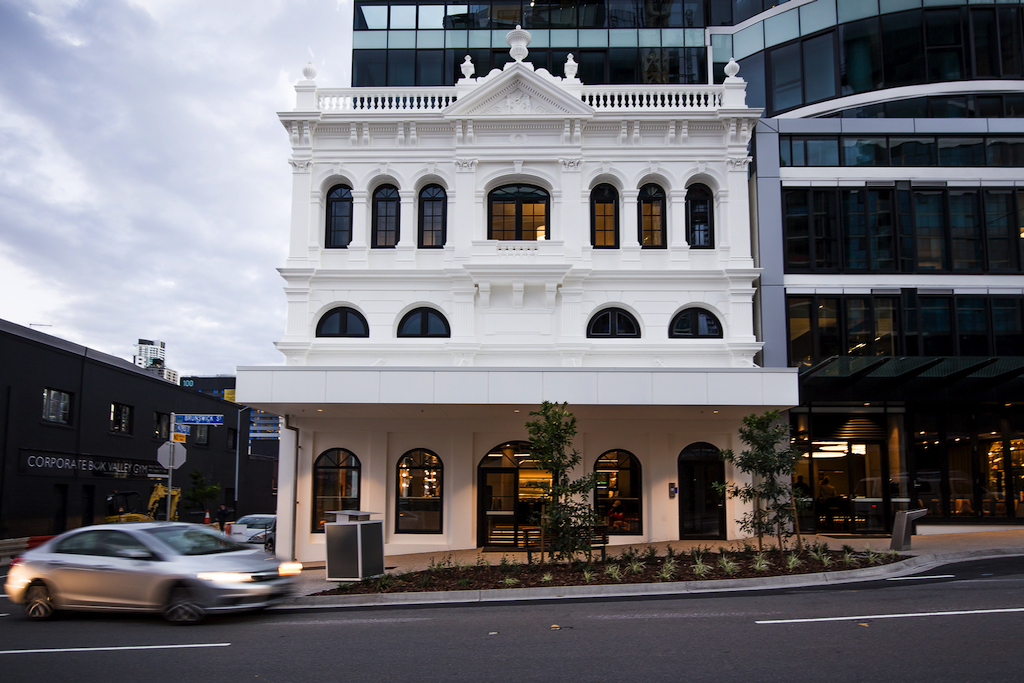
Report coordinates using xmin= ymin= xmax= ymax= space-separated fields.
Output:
xmin=594 ymin=451 xmax=643 ymax=536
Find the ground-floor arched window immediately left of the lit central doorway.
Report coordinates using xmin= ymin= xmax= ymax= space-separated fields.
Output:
xmin=394 ymin=449 xmax=444 ymax=533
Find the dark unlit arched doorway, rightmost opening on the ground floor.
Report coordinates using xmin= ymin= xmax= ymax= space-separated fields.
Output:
xmin=679 ymin=442 xmax=725 ymax=539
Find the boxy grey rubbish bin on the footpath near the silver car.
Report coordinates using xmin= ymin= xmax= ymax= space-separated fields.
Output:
xmin=324 ymin=510 xmax=384 ymax=581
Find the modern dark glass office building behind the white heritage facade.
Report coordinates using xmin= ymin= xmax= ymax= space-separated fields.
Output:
xmin=339 ymin=0 xmax=1024 ymax=532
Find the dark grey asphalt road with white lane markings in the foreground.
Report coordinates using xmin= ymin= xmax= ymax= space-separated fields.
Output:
xmin=0 ymin=558 xmax=1024 ymax=683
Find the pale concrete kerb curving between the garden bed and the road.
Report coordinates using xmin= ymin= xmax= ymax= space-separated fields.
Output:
xmin=273 ymin=548 xmax=1024 ymax=609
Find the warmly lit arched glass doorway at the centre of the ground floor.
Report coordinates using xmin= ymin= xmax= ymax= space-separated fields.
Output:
xmin=476 ymin=441 xmax=551 ymax=548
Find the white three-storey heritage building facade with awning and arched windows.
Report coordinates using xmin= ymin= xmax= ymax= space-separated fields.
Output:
xmin=237 ymin=30 xmax=798 ymax=561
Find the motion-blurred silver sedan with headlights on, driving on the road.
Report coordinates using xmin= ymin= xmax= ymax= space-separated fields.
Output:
xmin=4 ymin=522 xmax=302 ymax=624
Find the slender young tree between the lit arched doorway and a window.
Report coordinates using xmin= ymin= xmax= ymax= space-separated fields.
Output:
xmin=526 ymin=400 xmax=597 ymax=560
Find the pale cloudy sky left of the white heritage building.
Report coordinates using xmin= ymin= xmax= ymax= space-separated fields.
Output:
xmin=0 ymin=0 xmax=351 ymax=375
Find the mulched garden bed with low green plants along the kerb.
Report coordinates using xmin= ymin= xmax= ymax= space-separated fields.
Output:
xmin=314 ymin=544 xmax=906 ymax=595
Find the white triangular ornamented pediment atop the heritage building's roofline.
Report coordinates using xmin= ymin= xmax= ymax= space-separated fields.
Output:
xmin=444 ymin=62 xmax=594 ymax=119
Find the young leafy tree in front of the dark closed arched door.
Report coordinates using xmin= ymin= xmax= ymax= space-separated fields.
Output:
xmin=716 ymin=411 xmax=800 ymax=551
